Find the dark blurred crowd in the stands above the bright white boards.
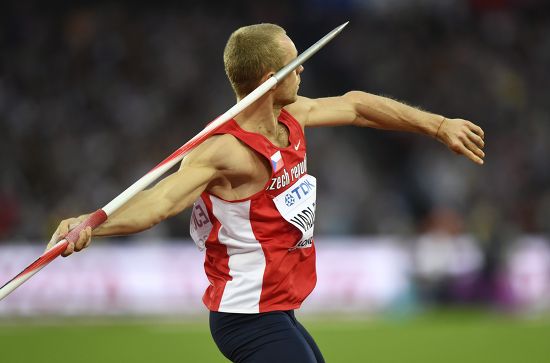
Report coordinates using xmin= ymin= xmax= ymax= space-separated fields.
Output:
xmin=0 ymin=0 xmax=550 ymax=255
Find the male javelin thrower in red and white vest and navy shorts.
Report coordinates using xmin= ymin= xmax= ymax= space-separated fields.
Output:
xmin=49 ymin=24 xmax=485 ymax=363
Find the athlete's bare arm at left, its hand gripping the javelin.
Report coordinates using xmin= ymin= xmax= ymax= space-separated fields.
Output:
xmin=48 ymin=139 xmax=226 ymax=257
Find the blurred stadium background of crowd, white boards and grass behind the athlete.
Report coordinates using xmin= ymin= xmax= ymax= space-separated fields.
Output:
xmin=0 ymin=0 xmax=550 ymax=363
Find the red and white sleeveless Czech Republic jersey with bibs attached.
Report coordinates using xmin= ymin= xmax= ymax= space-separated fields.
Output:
xmin=190 ymin=110 xmax=317 ymax=313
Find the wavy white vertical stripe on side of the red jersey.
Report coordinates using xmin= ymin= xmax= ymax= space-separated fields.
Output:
xmin=210 ymin=195 xmax=265 ymax=314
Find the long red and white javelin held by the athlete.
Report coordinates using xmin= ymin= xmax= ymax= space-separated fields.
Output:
xmin=0 ymin=22 xmax=349 ymax=300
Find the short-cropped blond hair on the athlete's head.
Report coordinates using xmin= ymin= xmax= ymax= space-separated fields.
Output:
xmin=223 ymin=23 xmax=286 ymax=97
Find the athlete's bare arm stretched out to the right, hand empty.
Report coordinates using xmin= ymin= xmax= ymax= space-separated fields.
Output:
xmin=287 ymin=91 xmax=485 ymax=165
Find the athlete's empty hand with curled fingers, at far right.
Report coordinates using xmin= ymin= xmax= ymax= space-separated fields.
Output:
xmin=436 ymin=118 xmax=485 ymax=165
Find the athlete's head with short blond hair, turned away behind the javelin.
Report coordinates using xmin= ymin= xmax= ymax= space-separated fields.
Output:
xmin=223 ymin=24 xmax=303 ymax=105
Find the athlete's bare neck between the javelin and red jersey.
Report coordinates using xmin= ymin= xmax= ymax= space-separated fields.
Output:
xmin=235 ymin=94 xmax=283 ymax=138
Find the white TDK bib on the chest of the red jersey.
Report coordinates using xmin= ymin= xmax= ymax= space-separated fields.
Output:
xmin=273 ymin=174 xmax=317 ymax=249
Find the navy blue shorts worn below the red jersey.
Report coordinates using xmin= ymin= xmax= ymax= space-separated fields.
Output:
xmin=210 ymin=310 xmax=325 ymax=363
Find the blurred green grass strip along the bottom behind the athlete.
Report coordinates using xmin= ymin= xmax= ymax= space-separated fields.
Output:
xmin=0 ymin=311 xmax=550 ymax=363
